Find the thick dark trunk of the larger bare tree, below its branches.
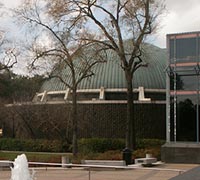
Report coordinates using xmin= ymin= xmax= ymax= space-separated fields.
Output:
xmin=126 ymin=72 xmax=136 ymax=150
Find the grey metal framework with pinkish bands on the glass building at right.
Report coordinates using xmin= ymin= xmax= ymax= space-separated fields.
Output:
xmin=166 ymin=32 xmax=200 ymax=143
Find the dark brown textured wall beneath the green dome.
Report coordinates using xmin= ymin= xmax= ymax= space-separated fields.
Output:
xmin=0 ymin=104 xmax=165 ymax=141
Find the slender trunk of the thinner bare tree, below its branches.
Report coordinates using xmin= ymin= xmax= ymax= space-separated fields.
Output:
xmin=72 ymin=88 xmax=78 ymax=156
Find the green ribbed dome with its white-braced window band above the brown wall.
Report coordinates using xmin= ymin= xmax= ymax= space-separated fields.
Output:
xmin=34 ymin=44 xmax=167 ymax=104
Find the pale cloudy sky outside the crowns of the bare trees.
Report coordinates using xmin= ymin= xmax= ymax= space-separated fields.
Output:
xmin=0 ymin=0 xmax=200 ymax=74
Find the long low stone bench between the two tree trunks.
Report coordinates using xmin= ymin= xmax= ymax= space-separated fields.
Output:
xmin=81 ymin=160 xmax=126 ymax=166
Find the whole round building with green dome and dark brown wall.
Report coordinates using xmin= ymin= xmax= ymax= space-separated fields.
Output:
xmin=0 ymin=41 xmax=167 ymax=142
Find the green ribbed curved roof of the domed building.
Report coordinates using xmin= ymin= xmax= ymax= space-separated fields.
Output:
xmin=40 ymin=44 xmax=167 ymax=92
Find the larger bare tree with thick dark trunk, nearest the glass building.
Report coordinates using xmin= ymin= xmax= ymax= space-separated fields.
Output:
xmin=47 ymin=0 xmax=164 ymax=150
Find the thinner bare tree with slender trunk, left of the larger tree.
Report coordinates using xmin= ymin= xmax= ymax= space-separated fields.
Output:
xmin=15 ymin=0 xmax=104 ymax=155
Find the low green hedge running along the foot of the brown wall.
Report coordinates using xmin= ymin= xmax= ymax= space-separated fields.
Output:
xmin=0 ymin=138 xmax=165 ymax=153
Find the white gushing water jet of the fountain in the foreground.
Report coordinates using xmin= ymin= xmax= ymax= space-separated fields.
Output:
xmin=10 ymin=154 xmax=34 ymax=180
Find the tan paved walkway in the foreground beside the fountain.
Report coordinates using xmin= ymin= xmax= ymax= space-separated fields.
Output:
xmin=0 ymin=164 xmax=198 ymax=180
